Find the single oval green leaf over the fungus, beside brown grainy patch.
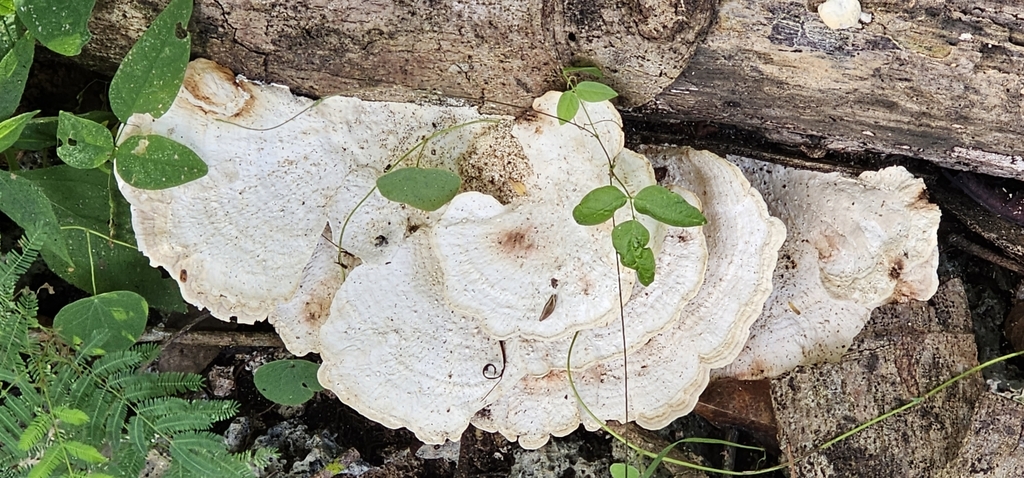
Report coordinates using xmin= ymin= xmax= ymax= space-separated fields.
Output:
xmin=377 ymin=168 xmax=462 ymax=211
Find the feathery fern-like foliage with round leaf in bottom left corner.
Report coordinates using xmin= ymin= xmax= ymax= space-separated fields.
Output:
xmin=0 ymin=236 xmax=270 ymax=477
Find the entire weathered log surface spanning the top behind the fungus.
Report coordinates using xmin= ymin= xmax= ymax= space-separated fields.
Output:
xmin=82 ymin=0 xmax=1024 ymax=179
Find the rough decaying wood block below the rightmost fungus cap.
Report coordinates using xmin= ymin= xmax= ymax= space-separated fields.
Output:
xmin=772 ymin=279 xmax=983 ymax=478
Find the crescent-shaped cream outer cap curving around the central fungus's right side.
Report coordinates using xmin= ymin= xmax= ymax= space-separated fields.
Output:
xmin=473 ymin=147 xmax=785 ymax=448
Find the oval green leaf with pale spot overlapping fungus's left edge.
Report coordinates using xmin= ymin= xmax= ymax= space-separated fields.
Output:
xmin=114 ymin=134 xmax=208 ymax=189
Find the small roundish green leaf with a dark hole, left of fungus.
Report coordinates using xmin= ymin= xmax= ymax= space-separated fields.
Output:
xmin=57 ymin=112 xmax=114 ymax=169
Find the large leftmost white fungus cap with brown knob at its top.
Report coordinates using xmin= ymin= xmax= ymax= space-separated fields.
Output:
xmin=118 ymin=59 xmax=489 ymax=323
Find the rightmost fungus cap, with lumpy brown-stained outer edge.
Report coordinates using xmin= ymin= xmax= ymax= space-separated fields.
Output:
xmin=720 ymin=157 xmax=940 ymax=380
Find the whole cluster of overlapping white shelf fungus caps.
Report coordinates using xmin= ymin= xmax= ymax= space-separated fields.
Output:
xmin=120 ymin=60 xmax=938 ymax=447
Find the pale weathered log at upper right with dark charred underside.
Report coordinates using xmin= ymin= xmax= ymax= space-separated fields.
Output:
xmin=631 ymin=0 xmax=1024 ymax=179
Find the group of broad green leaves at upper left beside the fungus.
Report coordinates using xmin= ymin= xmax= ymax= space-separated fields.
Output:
xmin=0 ymin=0 xmax=207 ymax=311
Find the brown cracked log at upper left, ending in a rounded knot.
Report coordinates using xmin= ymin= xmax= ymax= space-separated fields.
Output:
xmin=83 ymin=0 xmax=719 ymax=105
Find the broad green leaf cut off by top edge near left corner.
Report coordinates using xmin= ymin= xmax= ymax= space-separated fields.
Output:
xmin=14 ymin=0 xmax=96 ymax=56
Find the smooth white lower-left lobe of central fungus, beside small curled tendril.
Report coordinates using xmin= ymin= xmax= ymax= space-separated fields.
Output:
xmin=318 ymin=231 xmax=520 ymax=443
